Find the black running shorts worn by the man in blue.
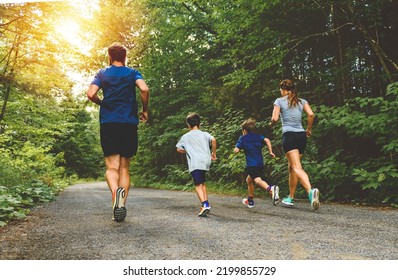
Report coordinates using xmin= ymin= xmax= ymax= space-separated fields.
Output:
xmin=100 ymin=123 xmax=138 ymax=157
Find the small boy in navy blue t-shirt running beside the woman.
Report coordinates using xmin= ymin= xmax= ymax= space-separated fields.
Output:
xmin=234 ymin=119 xmax=279 ymax=208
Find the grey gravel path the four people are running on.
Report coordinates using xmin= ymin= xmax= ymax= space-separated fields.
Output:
xmin=0 ymin=183 xmax=398 ymax=260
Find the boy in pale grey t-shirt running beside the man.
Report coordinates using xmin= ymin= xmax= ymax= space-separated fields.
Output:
xmin=176 ymin=113 xmax=217 ymax=217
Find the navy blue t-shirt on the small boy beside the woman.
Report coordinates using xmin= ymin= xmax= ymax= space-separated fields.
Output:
xmin=235 ymin=132 xmax=265 ymax=167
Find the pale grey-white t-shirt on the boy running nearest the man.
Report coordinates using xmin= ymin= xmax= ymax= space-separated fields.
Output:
xmin=176 ymin=130 xmax=214 ymax=172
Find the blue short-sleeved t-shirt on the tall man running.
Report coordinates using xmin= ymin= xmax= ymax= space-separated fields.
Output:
xmin=91 ymin=65 xmax=143 ymax=124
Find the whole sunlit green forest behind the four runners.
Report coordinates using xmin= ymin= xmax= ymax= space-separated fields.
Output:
xmin=0 ymin=0 xmax=398 ymax=226
